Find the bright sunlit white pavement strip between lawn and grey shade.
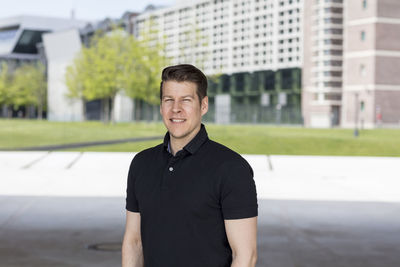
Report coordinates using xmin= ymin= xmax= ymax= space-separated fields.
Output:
xmin=0 ymin=152 xmax=400 ymax=202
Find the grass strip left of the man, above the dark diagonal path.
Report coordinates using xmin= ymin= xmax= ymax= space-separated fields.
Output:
xmin=0 ymin=119 xmax=164 ymax=148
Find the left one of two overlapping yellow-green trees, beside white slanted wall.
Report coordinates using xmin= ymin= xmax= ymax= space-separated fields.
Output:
xmin=65 ymin=30 xmax=125 ymax=122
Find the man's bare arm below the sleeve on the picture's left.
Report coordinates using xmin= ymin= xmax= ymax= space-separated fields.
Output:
xmin=122 ymin=211 xmax=144 ymax=267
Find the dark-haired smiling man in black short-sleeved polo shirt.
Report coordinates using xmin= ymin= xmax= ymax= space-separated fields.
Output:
xmin=122 ymin=64 xmax=257 ymax=267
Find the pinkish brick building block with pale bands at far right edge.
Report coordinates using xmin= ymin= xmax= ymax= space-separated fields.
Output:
xmin=341 ymin=0 xmax=400 ymax=128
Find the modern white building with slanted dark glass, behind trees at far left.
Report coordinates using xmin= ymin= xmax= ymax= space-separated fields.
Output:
xmin=0 ymin=12 xmax=137 ymax=121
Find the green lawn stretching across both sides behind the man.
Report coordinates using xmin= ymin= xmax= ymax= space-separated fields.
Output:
xmin=0 ymin=120 xmax=400 ymax=157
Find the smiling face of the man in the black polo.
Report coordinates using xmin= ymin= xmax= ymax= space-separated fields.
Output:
xmin=160 ymin=81 xmax=208 ymax=142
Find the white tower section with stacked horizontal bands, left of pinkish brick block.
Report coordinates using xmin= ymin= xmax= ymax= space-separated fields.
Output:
xmin=302 ymin=0 xmax=343 ymax=127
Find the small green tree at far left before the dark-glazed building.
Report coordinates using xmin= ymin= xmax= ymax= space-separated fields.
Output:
xmin=10 ymin=62 xmax=47 ymax=119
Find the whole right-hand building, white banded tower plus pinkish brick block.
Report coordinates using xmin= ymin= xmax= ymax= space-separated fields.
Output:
xmin=302 ymin=0 xmax=400 ymax=128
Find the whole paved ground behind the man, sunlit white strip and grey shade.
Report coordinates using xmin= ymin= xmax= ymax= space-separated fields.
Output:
xmin=0 ymin=152 xmax=400 ymax=267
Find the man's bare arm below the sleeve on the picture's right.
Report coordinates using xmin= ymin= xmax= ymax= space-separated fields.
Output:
xmin=225 ymin=217 xmax=257 ymax=267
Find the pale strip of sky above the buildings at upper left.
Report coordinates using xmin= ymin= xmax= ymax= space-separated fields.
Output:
xmin=0 ymin=0 xmax=175 ymax=20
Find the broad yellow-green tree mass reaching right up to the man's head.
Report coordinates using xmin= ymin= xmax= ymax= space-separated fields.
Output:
xmin=65 ymin=25 xmax=166 ymax=121
